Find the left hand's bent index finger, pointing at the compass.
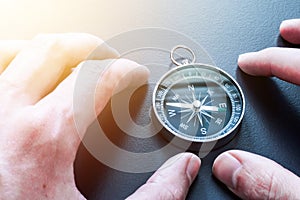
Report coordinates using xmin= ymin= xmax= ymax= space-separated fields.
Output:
xmin=35 ymin=59 xmax=149 ymax=147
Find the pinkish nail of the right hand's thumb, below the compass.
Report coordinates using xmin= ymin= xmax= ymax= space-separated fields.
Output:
xmin=213 ymin=153 xmax=242 ymax=188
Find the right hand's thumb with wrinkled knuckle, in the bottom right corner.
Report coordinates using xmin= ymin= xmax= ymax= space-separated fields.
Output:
xmin=213 ymin=150 xmax=300 ymax=199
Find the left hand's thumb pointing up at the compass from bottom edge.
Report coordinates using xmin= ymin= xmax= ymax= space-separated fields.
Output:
xmin=128 ymin=153 xmax=201 ymax=200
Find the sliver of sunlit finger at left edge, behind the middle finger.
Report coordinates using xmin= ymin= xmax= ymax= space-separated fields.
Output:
xmin=0 ymin=40 xmax=28 ymax=74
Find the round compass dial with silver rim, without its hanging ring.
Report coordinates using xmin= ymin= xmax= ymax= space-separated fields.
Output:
xmin=153 ymin=64 xmax=245 ymax=142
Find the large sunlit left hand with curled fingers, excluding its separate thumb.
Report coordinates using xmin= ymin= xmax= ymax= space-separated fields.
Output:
xmin=0 ymin=34 xmax=148 ymax=199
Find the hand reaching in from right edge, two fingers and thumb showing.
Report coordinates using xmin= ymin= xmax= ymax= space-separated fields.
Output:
xmin=213 ymin=19 xmax=300 ymax=199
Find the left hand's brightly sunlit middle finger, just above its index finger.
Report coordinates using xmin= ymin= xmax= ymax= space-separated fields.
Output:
xmin=1 ymin=34 xmax=117 ymax=105
